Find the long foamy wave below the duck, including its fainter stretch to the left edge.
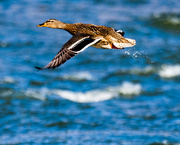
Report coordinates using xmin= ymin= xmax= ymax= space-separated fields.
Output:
xmin=0 ymin=82 xmax=142 ymax=103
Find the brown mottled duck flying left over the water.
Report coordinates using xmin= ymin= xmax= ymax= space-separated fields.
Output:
xmin=35 ymin=19 xmax=136 ymax=70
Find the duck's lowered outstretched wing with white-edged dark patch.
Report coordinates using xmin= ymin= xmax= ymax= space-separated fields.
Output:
xmin=35 ymin=33 xmax=100 ymax=70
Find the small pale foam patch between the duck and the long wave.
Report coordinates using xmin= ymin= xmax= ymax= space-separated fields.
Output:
xmin=63 ymin=71 xmax=96 ymax=81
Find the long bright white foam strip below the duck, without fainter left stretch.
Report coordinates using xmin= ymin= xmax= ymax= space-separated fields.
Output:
xmin=52 ymin=82 xmax=142 ymax=103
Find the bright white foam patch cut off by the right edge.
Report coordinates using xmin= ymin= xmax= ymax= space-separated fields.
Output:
xmin=159 ymin=65 xmax=180 ymax=78
